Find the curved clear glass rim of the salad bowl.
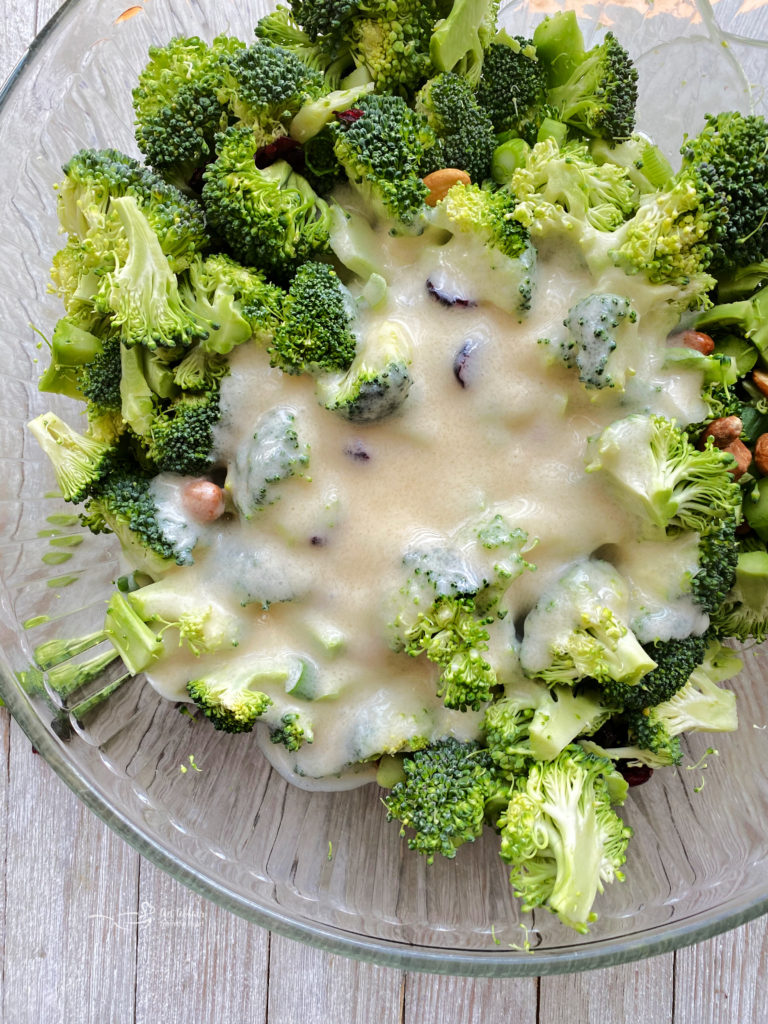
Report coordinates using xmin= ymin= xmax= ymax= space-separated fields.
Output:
xmin=0 ymin=0 xmax=768 ymax=978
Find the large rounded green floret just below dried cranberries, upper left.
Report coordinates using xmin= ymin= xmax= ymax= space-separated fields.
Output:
xmin=203 ymin=127 xmax=330 ymax=280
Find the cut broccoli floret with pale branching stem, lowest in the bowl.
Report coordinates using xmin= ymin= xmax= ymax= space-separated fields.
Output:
xmin=499 ymin=745 xmax=632 ymax=933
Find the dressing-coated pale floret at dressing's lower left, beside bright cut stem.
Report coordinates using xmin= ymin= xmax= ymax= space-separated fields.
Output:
xmin=121 ymin=577 xmax=241 ymax=656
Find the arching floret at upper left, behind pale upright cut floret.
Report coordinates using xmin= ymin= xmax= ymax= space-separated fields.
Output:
xmin=58 ymin=150 xmax=208 ymax=272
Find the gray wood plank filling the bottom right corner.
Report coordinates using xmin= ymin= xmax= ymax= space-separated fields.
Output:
xmin=674 ymin=918 xmax=768 ymax=1024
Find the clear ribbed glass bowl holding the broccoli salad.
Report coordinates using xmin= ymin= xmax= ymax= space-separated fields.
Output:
xmin=0 ymin=0 xmax=768 ymax=976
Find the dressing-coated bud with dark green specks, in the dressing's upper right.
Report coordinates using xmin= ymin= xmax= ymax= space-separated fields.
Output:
xmin=561 ymin=293 xmax=637 ymax=388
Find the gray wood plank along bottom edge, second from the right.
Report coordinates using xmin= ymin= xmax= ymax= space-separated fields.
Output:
xmin=539 ymin=953 xmax=671 ymax=1024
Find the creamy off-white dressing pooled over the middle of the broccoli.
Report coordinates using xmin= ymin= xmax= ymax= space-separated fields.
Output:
xmin=143 ymin=216 xmax=702 ymax=787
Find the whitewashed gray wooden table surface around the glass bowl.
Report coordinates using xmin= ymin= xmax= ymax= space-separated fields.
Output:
xmin=0 ymin=0 xmax=768 ymax=1024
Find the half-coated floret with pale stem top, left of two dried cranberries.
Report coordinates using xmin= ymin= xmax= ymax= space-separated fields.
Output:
xmin=318 ymin=321 xmax=413 ymax=423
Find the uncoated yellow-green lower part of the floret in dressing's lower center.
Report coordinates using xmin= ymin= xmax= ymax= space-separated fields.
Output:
xmin=406 ymin=596 xmax=497 ymax=711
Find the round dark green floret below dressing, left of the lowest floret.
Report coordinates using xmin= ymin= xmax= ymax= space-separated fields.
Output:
xmin=384 ymin=738 xmax=496 ymax=864
